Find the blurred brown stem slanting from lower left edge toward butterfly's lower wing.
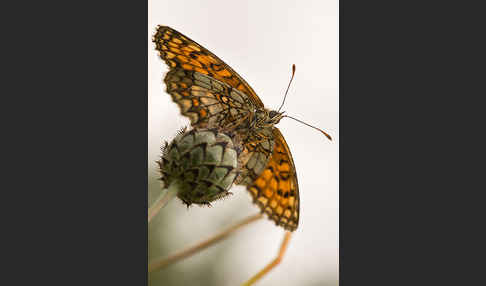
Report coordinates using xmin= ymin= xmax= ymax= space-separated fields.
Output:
xmin=148 ymin=213 xmax=263 ymax=272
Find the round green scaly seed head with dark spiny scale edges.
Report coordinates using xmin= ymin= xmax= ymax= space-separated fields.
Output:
xmin=157 ymin=128 xmax=238 ymax=206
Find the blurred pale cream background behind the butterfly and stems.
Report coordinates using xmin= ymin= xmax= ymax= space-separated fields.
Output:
xmin=147 ymin=0 xmax=339 ymax=286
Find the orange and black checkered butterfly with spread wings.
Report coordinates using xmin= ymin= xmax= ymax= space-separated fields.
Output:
xmin=152 ymin=26 xmax=328 ymax=231
